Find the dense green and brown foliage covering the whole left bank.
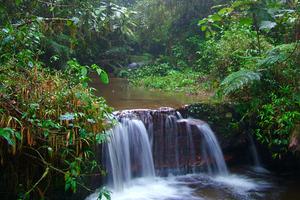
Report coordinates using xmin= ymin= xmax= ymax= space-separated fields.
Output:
xmin=0 ymin=0 xmax=119 ymax=199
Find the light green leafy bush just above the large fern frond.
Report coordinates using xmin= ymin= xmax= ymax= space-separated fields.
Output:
xmin=196 ymin=25 xmax=272 ymax=80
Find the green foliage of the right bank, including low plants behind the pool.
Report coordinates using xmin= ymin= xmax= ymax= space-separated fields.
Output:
xmin=121 ymin=0 xmax=300 ymax=158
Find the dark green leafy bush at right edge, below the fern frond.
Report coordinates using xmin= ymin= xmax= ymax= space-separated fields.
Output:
xmin=255 ymin=90 xmax=300 ymax=158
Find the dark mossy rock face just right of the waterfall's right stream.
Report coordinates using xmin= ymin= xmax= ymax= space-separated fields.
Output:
xmin=178 ymin=103 xmax=252 ymax=164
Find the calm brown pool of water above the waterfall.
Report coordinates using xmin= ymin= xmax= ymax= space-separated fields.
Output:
xmin=91 ymin=76 xmax=210 ymax=110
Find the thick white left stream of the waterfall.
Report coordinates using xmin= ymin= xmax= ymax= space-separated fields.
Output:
xmin=106 ymin=118 xmax=155 ymax=190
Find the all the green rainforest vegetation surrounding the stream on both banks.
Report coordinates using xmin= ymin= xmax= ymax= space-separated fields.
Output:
xmin=0 ymin=0 xmax=300 ymax=199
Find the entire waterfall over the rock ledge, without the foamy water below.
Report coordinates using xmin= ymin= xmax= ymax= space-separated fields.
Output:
xmin=106 ymin=108 xmax=228 ymax=191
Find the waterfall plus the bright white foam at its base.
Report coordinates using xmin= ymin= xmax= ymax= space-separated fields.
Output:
xmin=87 ymin=110 xmax=276 ymax=200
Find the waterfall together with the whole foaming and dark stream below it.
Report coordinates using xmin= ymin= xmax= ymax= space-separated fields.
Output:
xmin=87 ymin=77 xmax=300 ymax=200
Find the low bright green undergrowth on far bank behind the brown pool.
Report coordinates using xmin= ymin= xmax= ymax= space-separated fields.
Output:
xmin=119 ymin=63 xmax=212 ymax=95
